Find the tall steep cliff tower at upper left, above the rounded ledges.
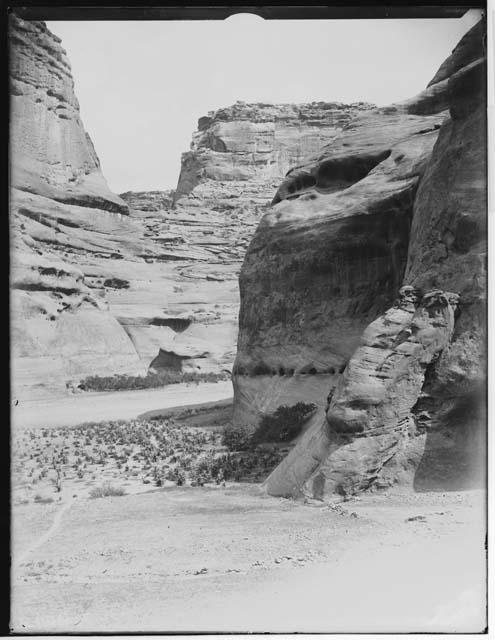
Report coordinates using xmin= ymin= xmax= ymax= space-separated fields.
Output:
xmin=10 ymin=15 xmax=128 ymax=214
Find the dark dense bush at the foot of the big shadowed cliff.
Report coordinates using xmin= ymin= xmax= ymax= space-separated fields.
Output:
xmin=253 ymin=402 xmax=316 ymax=443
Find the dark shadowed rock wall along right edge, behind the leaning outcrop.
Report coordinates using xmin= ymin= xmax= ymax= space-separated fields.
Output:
xmin=404 ymin=35 xmax=487 ymax=489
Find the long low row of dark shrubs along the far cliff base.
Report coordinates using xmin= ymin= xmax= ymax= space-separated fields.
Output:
xmin=79 ymin=371 xmax=230 ymax=391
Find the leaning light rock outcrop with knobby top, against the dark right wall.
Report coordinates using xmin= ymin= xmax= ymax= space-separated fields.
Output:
xmin=267 ymin=287 xmax=458 ymax=498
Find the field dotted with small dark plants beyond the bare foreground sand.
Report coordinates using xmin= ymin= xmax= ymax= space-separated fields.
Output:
xmin=13 ymin=418 xmax=286 ymax=501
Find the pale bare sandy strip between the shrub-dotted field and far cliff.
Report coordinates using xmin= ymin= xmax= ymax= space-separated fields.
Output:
xmin=12 ymin=380 xmax=232 ymax=429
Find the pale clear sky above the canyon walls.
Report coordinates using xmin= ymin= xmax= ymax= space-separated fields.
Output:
xmin=47 ymin=10 xmax=480 ymax=193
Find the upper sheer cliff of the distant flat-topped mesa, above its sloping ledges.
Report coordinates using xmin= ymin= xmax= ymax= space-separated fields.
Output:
xmin=175 ymin=102 xmax=373 ymax=204
